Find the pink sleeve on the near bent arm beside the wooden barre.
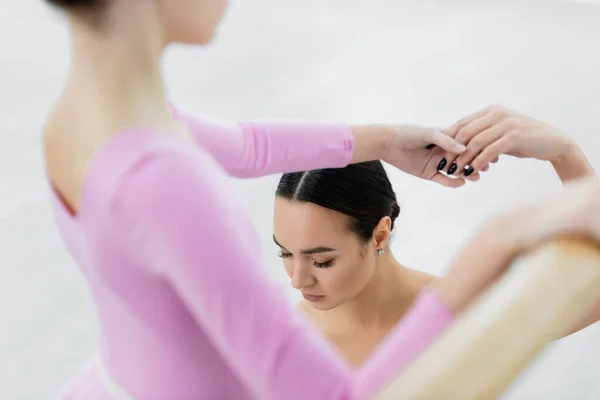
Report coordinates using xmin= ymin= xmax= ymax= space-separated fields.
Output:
xmin=113 ymin=151 xmax=453 ymax=400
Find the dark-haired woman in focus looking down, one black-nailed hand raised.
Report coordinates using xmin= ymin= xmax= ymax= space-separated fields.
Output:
xmin=274 ymin=107 xmax=600 ymax=366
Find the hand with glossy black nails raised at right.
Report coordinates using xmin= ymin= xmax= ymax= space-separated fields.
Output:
xmin=444 ymin=106 xmax=577 ymax=176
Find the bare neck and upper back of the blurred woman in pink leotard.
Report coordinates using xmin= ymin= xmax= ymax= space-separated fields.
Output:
xmin=44 ymin=7 xmax=181 ymax=213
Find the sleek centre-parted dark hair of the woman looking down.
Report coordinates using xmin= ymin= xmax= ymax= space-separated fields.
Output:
xmin=275 ymin=161 xmax=400 ymax=241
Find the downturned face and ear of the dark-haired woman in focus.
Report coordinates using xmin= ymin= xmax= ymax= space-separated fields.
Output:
xmin=273 ymin=197 xmax=426 ymax=316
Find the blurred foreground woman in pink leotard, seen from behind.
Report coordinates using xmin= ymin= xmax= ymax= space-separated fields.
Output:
xmin=44 ymin=0 xmax=600 ymax=400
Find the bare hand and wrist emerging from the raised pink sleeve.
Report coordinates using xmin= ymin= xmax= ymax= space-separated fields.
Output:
xmin=352 ymin=125 xmax=466 ymax=187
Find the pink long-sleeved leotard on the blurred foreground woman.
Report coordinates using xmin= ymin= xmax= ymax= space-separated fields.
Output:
xmin=53 ymin=108 xmax=453 ymax=400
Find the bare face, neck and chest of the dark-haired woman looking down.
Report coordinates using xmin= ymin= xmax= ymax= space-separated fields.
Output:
xmin=273 ymin=197 xmax=434 ymax=365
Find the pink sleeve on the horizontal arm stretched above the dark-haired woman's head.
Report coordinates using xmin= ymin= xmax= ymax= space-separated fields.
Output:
xmin=172 ymin=107 xmax=354 ymax=178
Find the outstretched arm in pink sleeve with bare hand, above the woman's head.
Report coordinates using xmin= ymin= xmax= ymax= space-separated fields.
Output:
xmin=172 ymin=107 xmax=465 ymax=187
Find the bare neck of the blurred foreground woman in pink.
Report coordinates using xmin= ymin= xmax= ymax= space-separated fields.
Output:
xmin=55 ymin=8 xmax=171 ymax=136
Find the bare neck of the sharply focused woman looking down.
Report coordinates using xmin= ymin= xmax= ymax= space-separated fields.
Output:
xmin=328 ymin=253 xmax=434 ymax=329
